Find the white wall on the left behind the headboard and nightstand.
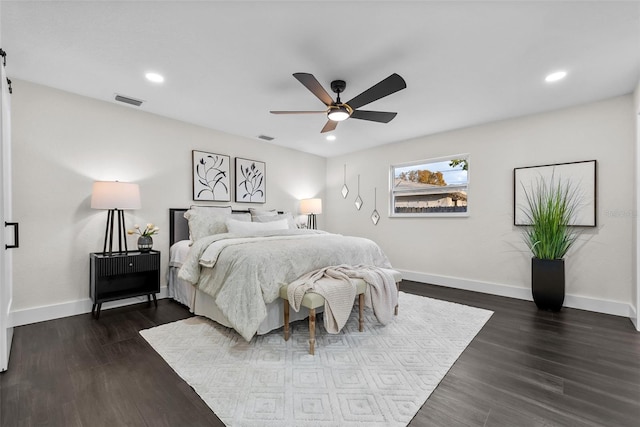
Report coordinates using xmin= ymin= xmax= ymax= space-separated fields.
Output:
xmin=12 ymin=80 xmax=326 ymax=324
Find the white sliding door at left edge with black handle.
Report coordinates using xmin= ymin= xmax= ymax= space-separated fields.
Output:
xmin=0 ymin=49 xmax=18 ymax=371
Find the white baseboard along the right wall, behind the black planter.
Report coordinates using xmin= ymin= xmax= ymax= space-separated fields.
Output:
xmin=398 ymin=270 xmax=638 ymax=320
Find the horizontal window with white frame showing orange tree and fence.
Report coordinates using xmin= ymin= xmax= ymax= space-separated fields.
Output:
xmin=389 ymin=154 xmax=469 ymax=217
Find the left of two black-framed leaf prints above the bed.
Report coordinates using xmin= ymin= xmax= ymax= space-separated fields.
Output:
xmin=192 ymin=150 xmax=231 ymax=202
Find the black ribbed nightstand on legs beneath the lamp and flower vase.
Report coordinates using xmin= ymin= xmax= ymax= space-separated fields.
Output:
xmin=90 ymin=251 xmax=160 ymax=319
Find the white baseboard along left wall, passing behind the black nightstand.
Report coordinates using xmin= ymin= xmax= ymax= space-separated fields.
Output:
xmin=9 ymin=287 xmax=167 ymax=327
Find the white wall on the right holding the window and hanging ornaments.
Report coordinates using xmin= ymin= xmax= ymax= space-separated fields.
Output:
xmin=324 ymin=96 xmax=635 ymax=316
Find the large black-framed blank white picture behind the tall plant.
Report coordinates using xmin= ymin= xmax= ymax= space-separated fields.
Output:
xmin=513 ymin=160 xmax=597 ymax=227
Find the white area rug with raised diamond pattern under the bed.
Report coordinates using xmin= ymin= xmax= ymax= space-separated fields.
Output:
xmin=140 ymin=292 xmax=492 ymax=427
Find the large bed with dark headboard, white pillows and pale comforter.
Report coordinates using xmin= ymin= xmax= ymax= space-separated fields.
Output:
xmin=167 ymin=207 xmax=391 ymax=340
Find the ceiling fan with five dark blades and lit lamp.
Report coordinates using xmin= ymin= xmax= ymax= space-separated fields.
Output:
xmin=271 ymin=73 xmax=407 ymax=133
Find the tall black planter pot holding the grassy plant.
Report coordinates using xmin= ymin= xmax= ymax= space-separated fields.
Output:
xmin=531 ymin=258 xmax=564 ymax=311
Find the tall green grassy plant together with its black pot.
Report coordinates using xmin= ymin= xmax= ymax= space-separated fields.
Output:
xmin=521 ymin=175 xmax=579 ymax=311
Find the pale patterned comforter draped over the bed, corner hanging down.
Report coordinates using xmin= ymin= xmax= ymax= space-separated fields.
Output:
xmin=179 ymin=230 xmax=391 ymax=341
